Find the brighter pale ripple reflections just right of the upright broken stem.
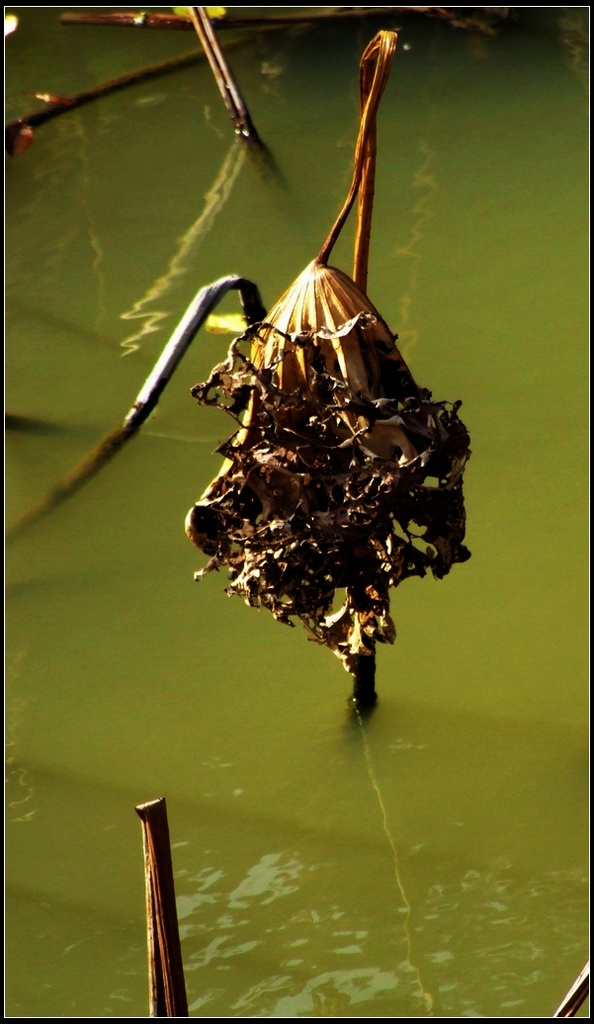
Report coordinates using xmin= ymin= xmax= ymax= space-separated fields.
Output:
xmin=177 ymin=853 xmax=431 ymax=1017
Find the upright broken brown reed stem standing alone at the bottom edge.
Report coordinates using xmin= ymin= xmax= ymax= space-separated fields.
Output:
xmin=135 ymin=797 xmax=189 ymax=1017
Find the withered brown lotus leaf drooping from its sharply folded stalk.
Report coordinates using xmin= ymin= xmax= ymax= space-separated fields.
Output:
xmin=185 ymin=31 xmax=470 ymax=703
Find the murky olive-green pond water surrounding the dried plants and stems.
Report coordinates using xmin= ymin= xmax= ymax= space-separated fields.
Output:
xmin=5 ymin=7 xmax=589 ymax=1018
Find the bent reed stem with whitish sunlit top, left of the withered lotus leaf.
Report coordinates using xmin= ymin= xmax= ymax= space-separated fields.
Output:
xmin=7 ymin=274 xmax=266 ymax=539
